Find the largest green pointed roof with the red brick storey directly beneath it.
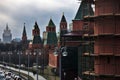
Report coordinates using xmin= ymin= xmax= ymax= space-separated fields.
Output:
xmin=73 ymin=0 xmax=94 ymax=32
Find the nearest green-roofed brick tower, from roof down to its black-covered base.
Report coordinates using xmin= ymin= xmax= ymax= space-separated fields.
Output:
xmin=61 ymin=0 xmax=94 ymax=80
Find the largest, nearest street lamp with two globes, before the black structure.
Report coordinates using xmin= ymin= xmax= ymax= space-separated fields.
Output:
xmin=54 ymin=47 xmax=68 ymax=80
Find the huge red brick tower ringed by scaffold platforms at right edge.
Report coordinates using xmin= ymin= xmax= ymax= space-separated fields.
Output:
xmin=85 ymin=0 xmax=120 ymax=80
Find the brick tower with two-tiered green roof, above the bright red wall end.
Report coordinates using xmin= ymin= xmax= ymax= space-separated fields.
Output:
xmin=44 ymin=19 xmax=57 ymax=68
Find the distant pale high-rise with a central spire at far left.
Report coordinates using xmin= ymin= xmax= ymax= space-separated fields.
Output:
xmin=3 ymin=25 xmax=12 ymax=43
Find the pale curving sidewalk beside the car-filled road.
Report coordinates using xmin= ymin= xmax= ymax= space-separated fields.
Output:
xmin=0 ymin=64 xmax=46 ymax=80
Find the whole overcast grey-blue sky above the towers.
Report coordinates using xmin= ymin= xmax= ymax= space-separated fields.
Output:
xmin=0 ymin=0 xmax=79 ymax=39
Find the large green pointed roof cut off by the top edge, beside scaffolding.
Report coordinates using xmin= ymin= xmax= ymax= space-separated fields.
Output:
xmin=74 ymin=0 xmax=94 ymax=20
